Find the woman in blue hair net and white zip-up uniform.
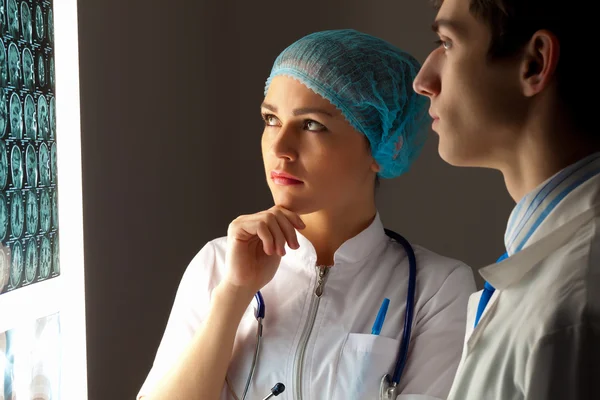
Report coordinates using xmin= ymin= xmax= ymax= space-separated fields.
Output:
xmin=138 ymin=30 xmax=476 ymax=400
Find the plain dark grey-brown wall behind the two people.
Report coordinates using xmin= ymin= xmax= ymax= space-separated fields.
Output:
xmin=79 ymin=0 xmax=512 ymax=400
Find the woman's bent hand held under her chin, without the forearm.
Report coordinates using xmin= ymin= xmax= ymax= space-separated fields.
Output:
xmin=225 ymin=206 xmax=305 ymax=294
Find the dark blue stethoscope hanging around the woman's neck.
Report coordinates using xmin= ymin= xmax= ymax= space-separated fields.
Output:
xmin=231 ymin=229 xmax=417 ymax=400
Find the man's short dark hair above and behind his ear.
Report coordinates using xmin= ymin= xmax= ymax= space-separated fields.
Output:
xmin=433 ymin=0 xmax=598 ymax=134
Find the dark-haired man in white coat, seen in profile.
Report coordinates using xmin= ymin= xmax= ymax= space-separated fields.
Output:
xmin=414 ymin=0 xmax=600 ymax=400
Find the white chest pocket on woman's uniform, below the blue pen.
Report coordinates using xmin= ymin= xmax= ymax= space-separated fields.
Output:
xmin=332 ymin=333 xmax=400 ymax=400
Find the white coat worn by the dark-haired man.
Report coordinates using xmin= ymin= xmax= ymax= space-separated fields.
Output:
xmin=449 ymin=170 xmax=600 ymax=400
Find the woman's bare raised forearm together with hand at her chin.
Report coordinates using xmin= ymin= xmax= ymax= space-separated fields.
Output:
xmin=143 ymin=206 xmax=304 ymax=400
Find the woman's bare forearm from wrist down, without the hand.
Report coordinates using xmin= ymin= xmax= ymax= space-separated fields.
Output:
xmin=145 ymin=283 xmax=254 ymax=400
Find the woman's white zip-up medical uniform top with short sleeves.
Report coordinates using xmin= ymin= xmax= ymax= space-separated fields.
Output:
xmin=138 ymin=215 xmax=476 ymax=400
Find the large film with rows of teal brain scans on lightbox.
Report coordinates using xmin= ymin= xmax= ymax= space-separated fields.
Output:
xmin=0 ymin=0 xmax=60 ymax=294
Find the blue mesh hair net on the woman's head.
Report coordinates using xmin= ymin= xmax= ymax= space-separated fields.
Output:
xmin=265 ymin=29 xmax=431 ymax=178
